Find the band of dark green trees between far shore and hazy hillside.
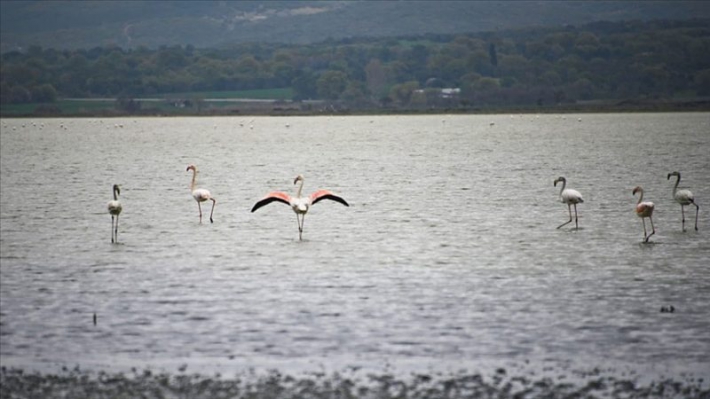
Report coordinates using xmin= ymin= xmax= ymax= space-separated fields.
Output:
xmin=0 ymin=19 xmax=710 ymax=109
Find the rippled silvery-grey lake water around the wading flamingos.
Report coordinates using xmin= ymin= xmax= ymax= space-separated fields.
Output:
xmin=0 ymin=113 xmax=710 ymax=388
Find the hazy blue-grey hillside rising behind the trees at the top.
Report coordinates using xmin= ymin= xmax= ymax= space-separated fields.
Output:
xmin=0 ymin=0 xmax=710 ymax=53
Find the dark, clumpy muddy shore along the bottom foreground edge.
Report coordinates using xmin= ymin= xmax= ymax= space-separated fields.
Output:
xmin=0 ymin=367 xmax=710 ymax=399
